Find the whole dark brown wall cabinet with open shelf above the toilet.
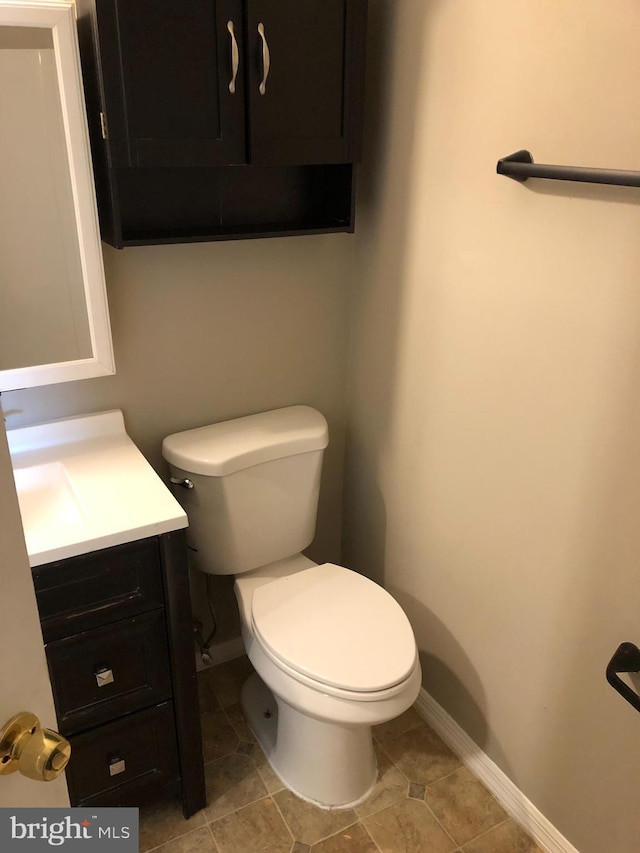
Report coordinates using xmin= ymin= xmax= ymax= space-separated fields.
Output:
xmin=77 ymin=0 xmax=367 ymax=248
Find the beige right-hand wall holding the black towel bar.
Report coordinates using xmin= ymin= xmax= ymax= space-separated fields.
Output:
xmin=345 ymin=0 xmax=640 ymax=853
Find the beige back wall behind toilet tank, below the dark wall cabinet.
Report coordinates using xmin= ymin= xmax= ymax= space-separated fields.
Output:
xmin=3 ymin=235 xmax=353 ymax=640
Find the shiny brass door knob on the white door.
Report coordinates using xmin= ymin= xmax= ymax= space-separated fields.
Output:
xmin=0 ymin=711 xmax=71 ymax=782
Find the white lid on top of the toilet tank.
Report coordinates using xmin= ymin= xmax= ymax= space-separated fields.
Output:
xmin=162 ymin=406 xmax=329 ymax=477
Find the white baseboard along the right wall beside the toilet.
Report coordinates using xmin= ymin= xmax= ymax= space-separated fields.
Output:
xmin=415 ymin=687 xmax=578 ymax=853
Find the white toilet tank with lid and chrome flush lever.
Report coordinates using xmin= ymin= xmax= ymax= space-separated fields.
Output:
xmin=162 ymin=406 xmax=329 ymax=575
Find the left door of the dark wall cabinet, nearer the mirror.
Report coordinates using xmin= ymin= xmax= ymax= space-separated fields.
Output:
xmin=97 ymin=0 xmax=246 ymax=166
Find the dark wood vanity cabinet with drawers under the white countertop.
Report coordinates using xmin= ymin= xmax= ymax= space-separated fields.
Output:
xmin=33 ymin=530 xmax=205 ymax=817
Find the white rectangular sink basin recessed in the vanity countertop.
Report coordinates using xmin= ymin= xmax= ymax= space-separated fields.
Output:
xmin=13 ymin=462 xmax=84 ymax=529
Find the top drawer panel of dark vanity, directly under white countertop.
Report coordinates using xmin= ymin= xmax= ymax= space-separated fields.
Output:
xmin=33 ymin=538 xmax=164 ymax=643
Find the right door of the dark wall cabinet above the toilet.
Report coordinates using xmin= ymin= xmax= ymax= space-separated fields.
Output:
xmin=247 ymin=0 xmax=366 ymax=165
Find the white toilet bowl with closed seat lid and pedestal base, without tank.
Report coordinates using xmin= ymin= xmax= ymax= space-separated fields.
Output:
xmin=235 ymin=555 xmax=421 ymax=808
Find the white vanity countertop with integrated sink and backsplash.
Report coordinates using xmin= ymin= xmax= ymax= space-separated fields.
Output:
xmin=7 ymin=410 xmax=188 ymax=566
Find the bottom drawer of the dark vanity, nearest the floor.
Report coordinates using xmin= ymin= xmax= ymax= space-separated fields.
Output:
xmin=66 ymin=702 xmax=180 ymax=806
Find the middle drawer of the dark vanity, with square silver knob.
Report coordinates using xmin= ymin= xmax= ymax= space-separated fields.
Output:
xmin=46 ymin=610 xmax=171 ymax=734
